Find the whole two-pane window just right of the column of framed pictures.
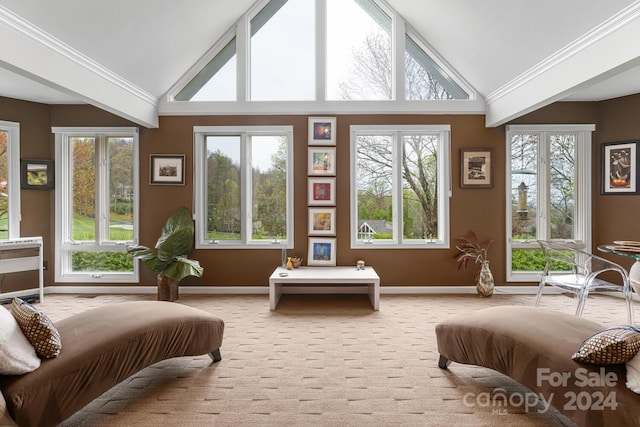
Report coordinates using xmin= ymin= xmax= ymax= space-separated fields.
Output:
xmin=351 ymin=125 xmax=450 ymax=248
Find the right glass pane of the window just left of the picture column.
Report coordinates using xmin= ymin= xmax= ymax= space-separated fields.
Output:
xmin=251 ymin=136 xmax=287 ymax=240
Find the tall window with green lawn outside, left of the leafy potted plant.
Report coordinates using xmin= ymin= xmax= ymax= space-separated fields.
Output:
xmin=53 ymin=128 xmax=138 ymax=282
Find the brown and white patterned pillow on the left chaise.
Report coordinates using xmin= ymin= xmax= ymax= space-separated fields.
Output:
xmin=11 ymin=298 xmax=62 ymax=359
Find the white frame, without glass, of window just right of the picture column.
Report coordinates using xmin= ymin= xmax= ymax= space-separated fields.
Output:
xmin=350 ymin=125 xmax=451 ymax=249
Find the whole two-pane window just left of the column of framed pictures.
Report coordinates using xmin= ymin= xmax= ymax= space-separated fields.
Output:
xmin=194 ymin=126 xmax=293 ymax=248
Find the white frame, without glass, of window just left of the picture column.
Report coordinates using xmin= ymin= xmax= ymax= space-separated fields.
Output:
xmin=193 ymin=125 xmax=294 ymax=249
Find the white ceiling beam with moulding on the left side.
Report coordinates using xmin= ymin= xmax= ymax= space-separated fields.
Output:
xmin=0 ymin=6 xmax=158 ymax=128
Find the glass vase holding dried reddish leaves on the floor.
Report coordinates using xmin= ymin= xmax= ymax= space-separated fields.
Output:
xmin=455 ymin=230 xmax=494 ymax=297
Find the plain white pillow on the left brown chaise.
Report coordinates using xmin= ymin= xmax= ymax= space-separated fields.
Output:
xmin=0 ymin=305 xmax=40 ymax=375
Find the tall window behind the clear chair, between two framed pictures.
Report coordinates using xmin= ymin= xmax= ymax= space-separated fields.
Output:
xmin=506 ymin=125 xmax=595 ymax=281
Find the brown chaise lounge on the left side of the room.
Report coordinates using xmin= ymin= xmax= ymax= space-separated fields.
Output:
xmin=0 ymin=301 xmax=224 ymax=427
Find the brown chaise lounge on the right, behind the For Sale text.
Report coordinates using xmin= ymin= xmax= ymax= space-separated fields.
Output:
xmin=436 ymin=306 xmax=640 ymax=426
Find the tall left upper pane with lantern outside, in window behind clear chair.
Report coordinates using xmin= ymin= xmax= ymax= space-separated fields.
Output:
xmin=511 ymin=134 xmax=539 ymax=241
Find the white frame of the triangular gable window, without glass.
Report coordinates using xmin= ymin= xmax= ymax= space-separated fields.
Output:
xmin=158 ymin=0 xmax=486 ymax=115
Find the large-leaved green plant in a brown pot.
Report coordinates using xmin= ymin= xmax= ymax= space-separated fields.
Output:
xmin=127 ymin=207 xmax=204 ymax=301
